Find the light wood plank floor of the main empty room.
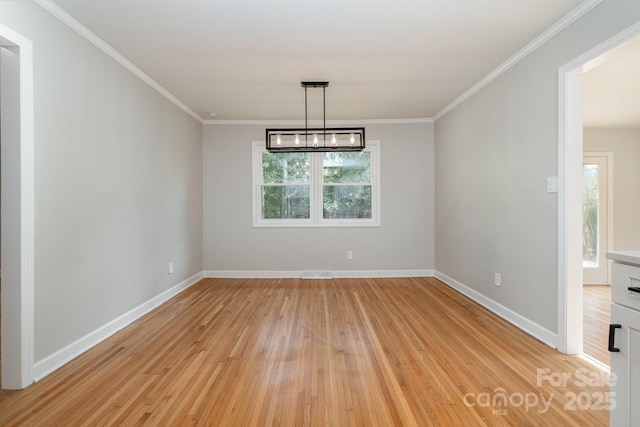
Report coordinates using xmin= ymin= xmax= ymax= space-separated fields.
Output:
xmin=0 ymin=278 xmax=609 ymax=426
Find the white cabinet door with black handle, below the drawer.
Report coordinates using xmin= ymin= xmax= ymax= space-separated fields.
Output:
xmin=611 ymin=304 xmax=640 ymax=427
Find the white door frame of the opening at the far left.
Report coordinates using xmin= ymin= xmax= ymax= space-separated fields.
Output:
xmin=0 ymin=24 xmax=35 ymax=389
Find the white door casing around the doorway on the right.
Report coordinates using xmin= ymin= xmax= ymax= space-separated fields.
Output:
xmin=558 ymin=18 xmax=640 ymax=354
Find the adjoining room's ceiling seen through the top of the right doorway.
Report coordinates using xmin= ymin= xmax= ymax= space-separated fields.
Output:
xmin=583 ymin=37 xmax=640 ymax=129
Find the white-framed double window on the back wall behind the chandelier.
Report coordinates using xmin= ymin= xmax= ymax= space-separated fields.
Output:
xmin=253 ymin=141 xmax=380 ymax=227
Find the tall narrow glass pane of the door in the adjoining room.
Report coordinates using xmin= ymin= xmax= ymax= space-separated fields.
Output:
xmin=582 ymin=165 xmax=599 ymax=267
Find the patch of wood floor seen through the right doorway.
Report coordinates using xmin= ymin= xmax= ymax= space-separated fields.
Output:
xmin=582 ymin=285 xmax=611 ymax=366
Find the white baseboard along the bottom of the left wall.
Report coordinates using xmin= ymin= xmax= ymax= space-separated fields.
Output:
xmin=34 ymin=273 xmax=203 ymax=381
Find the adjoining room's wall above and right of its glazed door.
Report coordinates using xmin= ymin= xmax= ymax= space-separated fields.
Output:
xmin=583 ymin=128 xmax=640 ymax=251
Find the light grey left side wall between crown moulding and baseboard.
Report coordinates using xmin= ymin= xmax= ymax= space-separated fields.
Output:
xmin=0 ymin=1 xmax=202 ymax=362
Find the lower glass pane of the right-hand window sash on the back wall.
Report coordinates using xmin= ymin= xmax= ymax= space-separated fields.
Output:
xmin=322 ymin=185 xmax=371 ymax=218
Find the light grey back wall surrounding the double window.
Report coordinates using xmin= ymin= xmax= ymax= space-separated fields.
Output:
xmin=203 ymin=123 xmax=434 ymax=273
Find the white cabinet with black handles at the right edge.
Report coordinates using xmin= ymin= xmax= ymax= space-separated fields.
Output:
xmin=607 ymin=252 xmax=640 ymax=427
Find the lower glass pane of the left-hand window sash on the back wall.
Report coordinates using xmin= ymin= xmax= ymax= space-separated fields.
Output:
xmin=262 ymin=185 xmax=310 ymax=219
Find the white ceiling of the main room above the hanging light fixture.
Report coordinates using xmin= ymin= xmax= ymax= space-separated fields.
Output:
xmin=55 ymin=0 xmax=583 ymax=120
